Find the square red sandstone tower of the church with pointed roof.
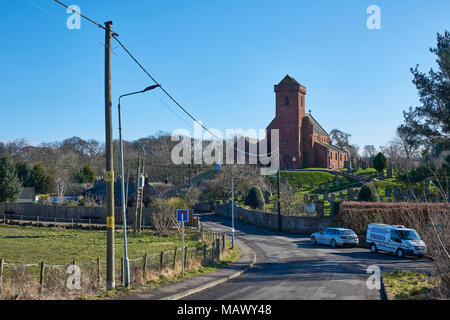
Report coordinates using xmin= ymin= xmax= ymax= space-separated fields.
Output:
xmin=268 ymin=75 xmax=306 ymax=168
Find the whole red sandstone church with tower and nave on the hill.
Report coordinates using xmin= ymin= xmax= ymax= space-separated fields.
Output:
xmin=266 ymin=75 xmax=348 ymax=169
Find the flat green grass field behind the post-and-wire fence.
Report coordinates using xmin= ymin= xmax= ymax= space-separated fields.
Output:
xmin=0 ymin=225 xmax=200 ymax=264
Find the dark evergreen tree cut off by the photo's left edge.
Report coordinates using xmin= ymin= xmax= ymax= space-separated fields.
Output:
xmin=0 ymin=154 xmax=22 ymax=202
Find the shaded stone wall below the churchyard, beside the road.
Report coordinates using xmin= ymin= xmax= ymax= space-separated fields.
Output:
xmin=216 ymin=203 xmax=339 ymax=234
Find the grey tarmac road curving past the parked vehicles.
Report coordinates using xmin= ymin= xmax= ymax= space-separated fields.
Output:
xmin=184 ymin=214 xmax=432 ymax=300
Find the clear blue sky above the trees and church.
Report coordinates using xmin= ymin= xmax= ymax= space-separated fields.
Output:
xmin=0 ymin=0 xmax=450 ymax=147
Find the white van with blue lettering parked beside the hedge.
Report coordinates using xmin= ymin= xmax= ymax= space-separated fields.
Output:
xmin=366 ymin=223 xmax=427 ymax=258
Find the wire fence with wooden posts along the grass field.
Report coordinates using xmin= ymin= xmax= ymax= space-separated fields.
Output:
xmin=0 ymin=226 xmax=229 ymax=300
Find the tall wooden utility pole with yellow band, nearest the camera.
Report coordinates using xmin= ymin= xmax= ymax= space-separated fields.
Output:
xmin=105 ymin=21 xmax=116 ymax=290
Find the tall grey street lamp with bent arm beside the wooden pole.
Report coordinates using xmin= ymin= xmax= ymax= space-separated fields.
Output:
xmin=118 ymin=84 xmax=160 ymax=287
